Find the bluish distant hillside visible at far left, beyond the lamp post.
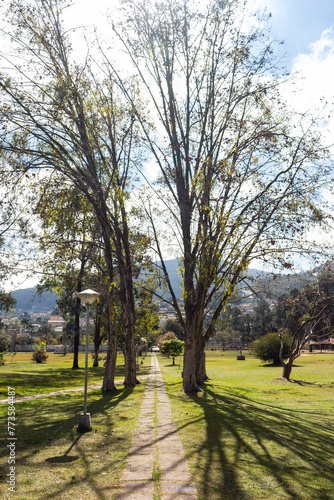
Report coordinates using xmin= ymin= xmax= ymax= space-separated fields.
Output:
xmin=12 ymin=288 xmax=56 ymax=313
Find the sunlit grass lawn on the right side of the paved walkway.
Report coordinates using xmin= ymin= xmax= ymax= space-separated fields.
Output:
xmin=159 ymin=351 xmax=334 ymax=500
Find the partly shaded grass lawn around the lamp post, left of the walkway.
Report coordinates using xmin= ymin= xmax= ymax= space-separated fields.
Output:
xmin=0 ymin=354 xmax=150 ymax=500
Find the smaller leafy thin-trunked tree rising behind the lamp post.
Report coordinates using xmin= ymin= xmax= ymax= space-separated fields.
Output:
xmin=35 ymin=182 xmax=98 ymax=369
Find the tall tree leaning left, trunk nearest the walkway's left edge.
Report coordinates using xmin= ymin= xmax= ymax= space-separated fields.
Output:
xmin=0 ymin=0 xmax=146 ymax=385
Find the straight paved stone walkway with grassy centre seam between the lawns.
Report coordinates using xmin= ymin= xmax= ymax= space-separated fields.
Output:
xmin=117 ymin=353 xmax=197 ymax=500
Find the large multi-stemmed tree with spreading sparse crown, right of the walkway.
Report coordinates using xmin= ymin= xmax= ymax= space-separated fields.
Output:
xmin=113 ymin=0 xmax=332 ymax=391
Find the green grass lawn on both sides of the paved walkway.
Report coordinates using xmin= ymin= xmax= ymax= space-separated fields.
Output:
xmin=0 ymin=351 xmax=334 ymax=500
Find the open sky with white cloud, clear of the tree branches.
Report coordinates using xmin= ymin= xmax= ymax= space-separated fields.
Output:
xmin=4 ymin=0 xmax=334 ymax=289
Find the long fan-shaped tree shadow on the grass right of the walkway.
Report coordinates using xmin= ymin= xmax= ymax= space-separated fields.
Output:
xmin=187 ymin=385 xmax=334 ymax=500
